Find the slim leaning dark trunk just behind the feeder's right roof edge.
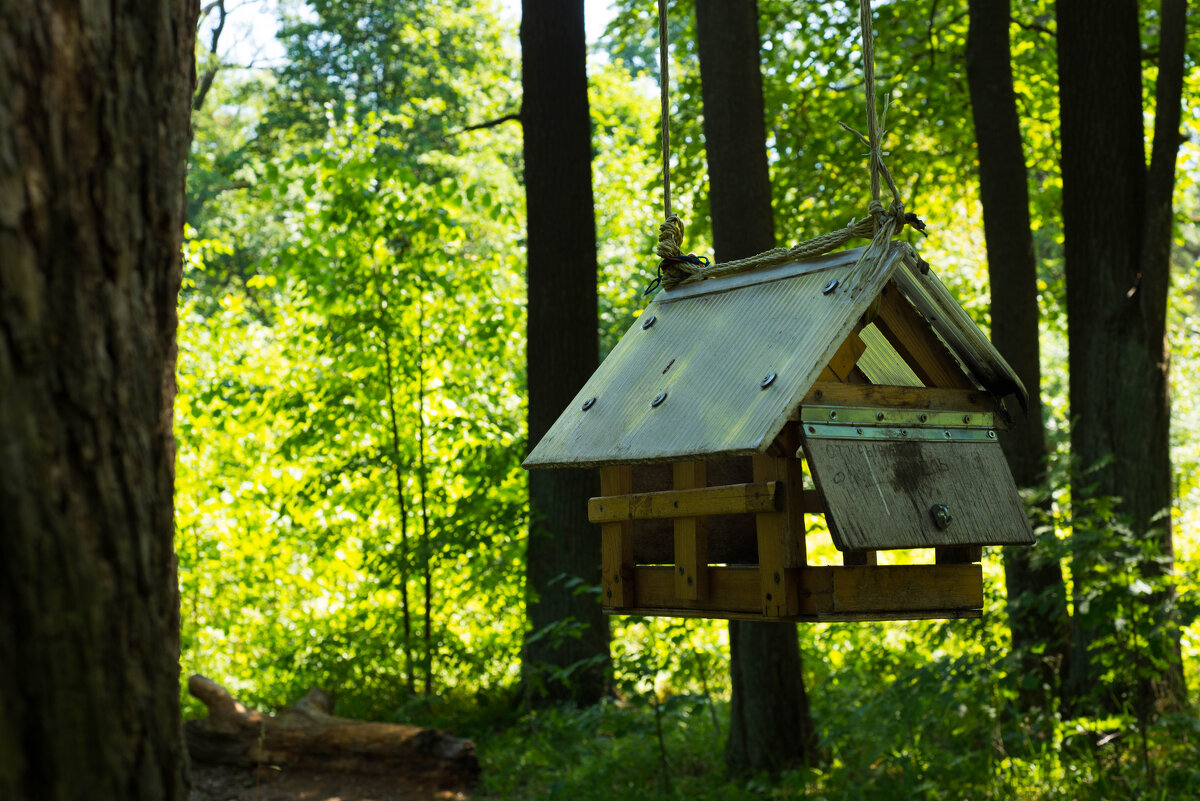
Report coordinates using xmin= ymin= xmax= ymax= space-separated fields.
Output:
xmin=967 ymin=0 xmax=1070 ymax=706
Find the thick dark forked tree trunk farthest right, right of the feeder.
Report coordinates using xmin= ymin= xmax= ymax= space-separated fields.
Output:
xmin=1057 ymin=0 xmax=1186 ymax=704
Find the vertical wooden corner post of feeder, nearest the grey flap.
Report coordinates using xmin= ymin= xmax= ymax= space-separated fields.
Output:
xmin=754 ymin=454 xmax=806 ymax=618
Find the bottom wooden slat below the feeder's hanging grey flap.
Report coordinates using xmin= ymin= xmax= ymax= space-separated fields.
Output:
xmin=796 ymin=565 xmax=983 ymax=614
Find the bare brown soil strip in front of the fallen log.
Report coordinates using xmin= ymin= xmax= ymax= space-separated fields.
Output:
xmin=190 ymin=764 xmax=470 ymax=801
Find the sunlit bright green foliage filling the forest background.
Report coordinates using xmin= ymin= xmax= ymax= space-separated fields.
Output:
xmin=176 ymin=0 xmax=1200 ymax=800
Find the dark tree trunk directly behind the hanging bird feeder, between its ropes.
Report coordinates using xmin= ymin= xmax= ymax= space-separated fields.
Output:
xmin=696 ymin=0 xmax=816 ymax=771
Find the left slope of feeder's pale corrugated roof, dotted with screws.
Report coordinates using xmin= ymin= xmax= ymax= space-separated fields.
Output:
xmin=524 ymin=245 xmax=907 ymax=468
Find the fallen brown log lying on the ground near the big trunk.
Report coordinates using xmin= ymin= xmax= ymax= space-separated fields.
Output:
xmin=184 ymin=675 xmax=479 ymax=788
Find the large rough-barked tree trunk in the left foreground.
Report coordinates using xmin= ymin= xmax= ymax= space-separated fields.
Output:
xmin=0 ymin=0 xmax=198 ymax=801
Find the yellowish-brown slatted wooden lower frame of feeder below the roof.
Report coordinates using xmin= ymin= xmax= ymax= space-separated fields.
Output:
xmin=588 ymin=422 xmax=983 ymax=621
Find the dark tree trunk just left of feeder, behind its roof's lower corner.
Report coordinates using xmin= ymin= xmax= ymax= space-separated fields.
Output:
xmin=521 ymin=0 xmax=608 ymax=704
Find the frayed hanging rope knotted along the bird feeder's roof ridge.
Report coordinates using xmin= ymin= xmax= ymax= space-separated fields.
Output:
xmin=646 ymin=0 xmax=925 ymax=294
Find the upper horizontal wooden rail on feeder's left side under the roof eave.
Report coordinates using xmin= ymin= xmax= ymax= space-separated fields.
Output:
xmin=588 ymin=482 xmax=779 ymax=523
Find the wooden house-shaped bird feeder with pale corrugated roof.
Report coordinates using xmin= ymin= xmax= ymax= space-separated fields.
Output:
xmin=524 ymin=243 xmax=1033 ymax=621
